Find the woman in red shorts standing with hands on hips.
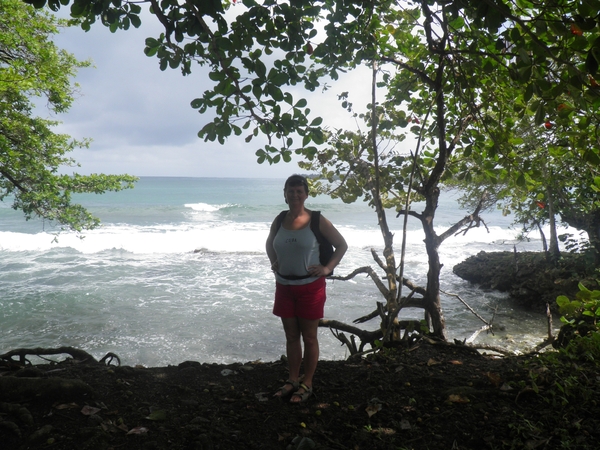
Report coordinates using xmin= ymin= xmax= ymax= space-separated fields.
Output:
xmin=266 ymin=175 xmax=348 ymax=403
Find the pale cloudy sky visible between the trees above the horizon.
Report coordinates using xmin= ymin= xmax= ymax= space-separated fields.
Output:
xmin=49 ymin=10 xmax=370 ymax=178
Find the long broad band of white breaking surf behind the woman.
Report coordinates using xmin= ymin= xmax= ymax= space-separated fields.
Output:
xmin=0 ymin=222 xmax=568 ymax=260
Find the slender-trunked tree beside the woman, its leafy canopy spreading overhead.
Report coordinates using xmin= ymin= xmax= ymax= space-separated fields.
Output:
xmin=30 ymin=0 xmax=600 ymax=344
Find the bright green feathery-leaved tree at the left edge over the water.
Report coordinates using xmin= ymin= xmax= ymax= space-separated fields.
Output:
xmin=0 ymin=0 xmax=135 ymax=231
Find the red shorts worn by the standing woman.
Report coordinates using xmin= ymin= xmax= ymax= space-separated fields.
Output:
xmin=273 ymin=277 xmax=327 ymax=320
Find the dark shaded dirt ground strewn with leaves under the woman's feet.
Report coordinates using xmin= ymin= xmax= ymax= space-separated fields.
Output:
xmin=0 ymin=340 xmax=600 ymax=450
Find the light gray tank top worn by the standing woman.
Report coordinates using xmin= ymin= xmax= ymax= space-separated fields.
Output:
xmin=273 ymin=223 xmax=319 ymax=285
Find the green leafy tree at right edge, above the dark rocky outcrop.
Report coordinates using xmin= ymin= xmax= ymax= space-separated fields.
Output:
xmin=446 ymin=2 xmax=600 ymax=265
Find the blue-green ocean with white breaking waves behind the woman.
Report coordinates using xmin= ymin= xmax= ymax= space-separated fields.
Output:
xmin=0 ymin=177 xmax=547 ymax=366
